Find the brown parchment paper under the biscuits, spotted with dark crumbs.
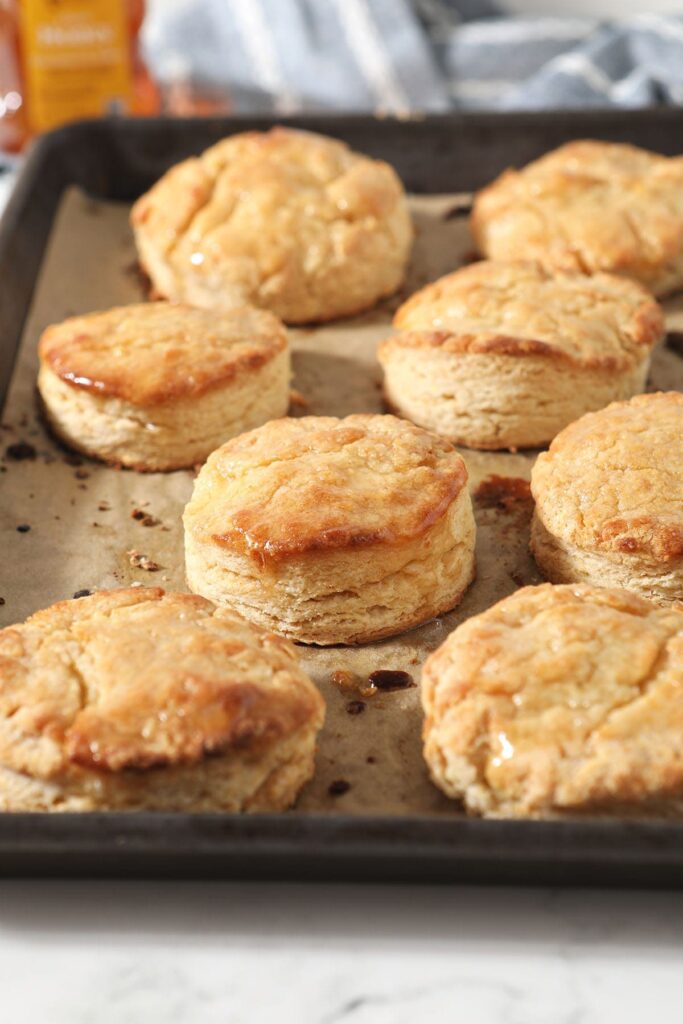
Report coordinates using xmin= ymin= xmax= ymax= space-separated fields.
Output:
xmin=0 ymin=189 xmax=683 ymax=816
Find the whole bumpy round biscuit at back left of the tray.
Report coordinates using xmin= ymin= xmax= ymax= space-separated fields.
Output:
xmin=131 ymin=128 xmax=413 ymax=324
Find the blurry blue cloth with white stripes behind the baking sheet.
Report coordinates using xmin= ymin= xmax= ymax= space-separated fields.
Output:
xmin=144 ymin=0 xmax=683 ymax=115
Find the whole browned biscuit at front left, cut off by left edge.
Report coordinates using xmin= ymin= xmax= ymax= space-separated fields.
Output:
xmin=0 ymin=588 xmax=325 ymax=811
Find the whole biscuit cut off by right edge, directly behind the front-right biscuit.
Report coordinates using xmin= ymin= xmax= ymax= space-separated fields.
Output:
xmin=531 ymin=391 xmax=683 ymax=604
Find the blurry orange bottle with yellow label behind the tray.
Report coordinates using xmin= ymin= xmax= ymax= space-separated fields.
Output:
xmin=0 ymin=0 xmax=159 ymax=148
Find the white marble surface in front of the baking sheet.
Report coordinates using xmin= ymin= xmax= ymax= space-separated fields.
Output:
xmin=0 ymin=882 xmax=683 ymax=1024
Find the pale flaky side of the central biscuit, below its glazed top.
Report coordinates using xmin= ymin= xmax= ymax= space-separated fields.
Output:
xmin=185 ymin=489 xmax=475 ymax=645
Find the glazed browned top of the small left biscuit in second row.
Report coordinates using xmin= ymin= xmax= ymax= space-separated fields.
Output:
xmin=39 ymin=302 xmax=288 ymax=406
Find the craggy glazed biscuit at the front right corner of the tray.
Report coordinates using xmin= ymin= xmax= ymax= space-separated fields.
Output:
xmin=422 ymin=584 xmax=683 ymax=817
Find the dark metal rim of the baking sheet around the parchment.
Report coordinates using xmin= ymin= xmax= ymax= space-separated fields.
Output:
xmin=0 ymin=111 xmax=683 ymax=887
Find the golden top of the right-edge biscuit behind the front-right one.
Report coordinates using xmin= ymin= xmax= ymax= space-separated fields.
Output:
xmin=531 ymin=391 xmax=683 ymax=562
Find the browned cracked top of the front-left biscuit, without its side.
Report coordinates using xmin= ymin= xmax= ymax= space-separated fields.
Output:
xmin=0 ymin=588 xmax=323 ymax=779
